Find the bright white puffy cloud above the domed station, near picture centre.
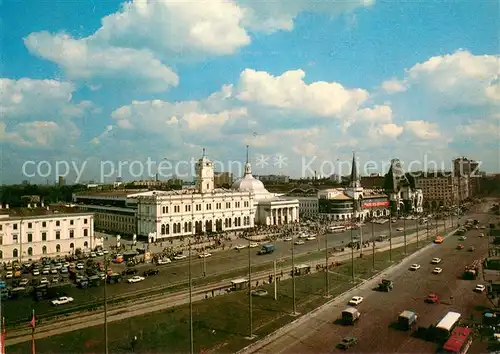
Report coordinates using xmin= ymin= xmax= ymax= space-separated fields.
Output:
xmin=236 ymin=69 xmax=368 ymax=117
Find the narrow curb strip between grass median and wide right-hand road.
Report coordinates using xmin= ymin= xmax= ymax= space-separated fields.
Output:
xmin=236 ymin=228 xmax=458 ymax=354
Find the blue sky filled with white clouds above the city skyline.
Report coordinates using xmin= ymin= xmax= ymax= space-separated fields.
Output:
xmin=0 ymin=0 xmax=500 ymax=184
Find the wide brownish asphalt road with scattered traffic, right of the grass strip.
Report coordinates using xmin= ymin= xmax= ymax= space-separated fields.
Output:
xmin=244 ymin=202 xmax=496 ymax=354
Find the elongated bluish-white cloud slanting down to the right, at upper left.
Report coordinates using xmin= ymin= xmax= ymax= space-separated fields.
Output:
xmin=24 ymin=32 xmax=179 ymax=91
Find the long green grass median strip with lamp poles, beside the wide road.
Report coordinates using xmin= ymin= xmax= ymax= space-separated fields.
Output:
xmin=7 ymin=240 xmax=428 ymax=353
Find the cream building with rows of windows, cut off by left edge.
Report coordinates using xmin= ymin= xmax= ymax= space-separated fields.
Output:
xmin=0 ymin=205 xmax=102 ymax=262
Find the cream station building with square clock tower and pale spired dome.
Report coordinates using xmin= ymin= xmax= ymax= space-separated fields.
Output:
xmin=137 ymin=146 xmax=299 ymax=242
